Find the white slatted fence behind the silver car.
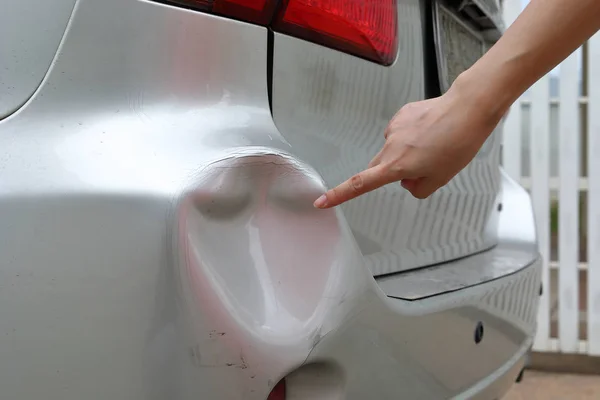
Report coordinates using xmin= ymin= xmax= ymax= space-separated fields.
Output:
xmin=503 ymin=0 xmax=600 ymax=356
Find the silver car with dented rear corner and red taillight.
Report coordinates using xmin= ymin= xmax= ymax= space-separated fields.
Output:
xmin=0 ymin=0 xmax=540 ymax=400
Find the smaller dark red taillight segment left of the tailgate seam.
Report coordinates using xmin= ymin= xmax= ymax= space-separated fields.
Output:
xmin=169 ymin=0 xmax=277 ymax=25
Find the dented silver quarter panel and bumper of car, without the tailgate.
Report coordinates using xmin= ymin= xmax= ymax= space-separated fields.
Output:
xmin=0 ymin=0 xmax=539 ymax=400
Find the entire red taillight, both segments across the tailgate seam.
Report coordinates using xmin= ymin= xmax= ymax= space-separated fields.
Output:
xmin=159 ymin=0 xmax=397 ymax=65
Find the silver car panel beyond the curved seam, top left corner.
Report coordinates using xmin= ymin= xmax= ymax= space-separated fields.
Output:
xmin=0 ymin=0 xmax=76 ymax=120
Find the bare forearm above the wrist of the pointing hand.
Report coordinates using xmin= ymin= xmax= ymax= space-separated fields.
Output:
xmin=453 ymin=0 xmax=600 ymax=123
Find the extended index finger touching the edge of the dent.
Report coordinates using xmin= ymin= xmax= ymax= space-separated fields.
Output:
xmin=314 ymin=165 xmax=395 ymax=208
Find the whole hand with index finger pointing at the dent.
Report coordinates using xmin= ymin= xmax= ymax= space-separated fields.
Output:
xmin=314 ymin=85 xmax=502 ymax=208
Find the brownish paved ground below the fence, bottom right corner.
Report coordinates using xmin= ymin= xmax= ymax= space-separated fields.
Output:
xmin=503 ymin=371 xmax=600 ymax=400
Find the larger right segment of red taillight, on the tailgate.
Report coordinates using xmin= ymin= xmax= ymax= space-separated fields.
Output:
xmin=273 ymin=0 xmax=397 ymax=65
